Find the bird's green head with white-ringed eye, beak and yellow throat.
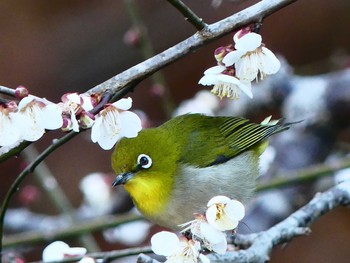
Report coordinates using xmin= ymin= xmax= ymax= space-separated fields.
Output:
xmin=112 ymin=128 xmax=179 ymax=216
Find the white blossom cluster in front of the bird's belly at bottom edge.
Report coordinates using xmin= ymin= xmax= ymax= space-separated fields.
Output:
xmin=151 ymin=196 xmax=245 ymax=263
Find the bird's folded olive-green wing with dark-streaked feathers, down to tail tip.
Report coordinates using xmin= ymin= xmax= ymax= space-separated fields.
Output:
xmin=182 ymin=116 xmax=289 ymax=167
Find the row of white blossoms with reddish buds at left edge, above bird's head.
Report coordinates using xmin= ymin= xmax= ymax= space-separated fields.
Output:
xmin=0 ymin=86 xmax=141 ymax=153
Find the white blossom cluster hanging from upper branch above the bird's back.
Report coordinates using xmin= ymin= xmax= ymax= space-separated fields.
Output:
xmin=198 ymin=27 xmax=281 ymax=99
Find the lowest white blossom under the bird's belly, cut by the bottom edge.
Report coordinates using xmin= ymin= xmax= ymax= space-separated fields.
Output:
xmin=151 ymin=231 xmax=209 ymax=263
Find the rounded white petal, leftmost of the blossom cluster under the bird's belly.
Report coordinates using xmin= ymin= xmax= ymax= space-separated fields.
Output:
xmin=151 ymin=231 xmax=180 ymax=256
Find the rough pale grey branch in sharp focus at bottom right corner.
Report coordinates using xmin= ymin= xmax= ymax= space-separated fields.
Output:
xmin=209 ymin=180 xmax=350 ymax=263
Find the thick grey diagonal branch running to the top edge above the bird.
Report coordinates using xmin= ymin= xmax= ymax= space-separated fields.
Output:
xmin=87 ymin=0 xmax=296 ymax=97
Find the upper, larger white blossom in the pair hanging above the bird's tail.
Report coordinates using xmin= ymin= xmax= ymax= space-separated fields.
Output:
xmin=222 ymin=30 xmax=281 ymax=82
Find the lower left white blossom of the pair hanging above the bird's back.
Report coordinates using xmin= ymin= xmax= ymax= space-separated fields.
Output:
xmin=198 ymin=65 xmax=253 ymax=99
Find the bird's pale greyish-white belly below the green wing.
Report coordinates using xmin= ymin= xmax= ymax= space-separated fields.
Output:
xmin=156 ymin=151 xmax=259 ymax=229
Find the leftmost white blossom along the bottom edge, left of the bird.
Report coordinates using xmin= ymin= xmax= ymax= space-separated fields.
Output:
xmin=42 ymin=241 xmax=87 ymax=262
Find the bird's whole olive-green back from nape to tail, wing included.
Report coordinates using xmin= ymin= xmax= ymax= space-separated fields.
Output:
xmin=160 ymin=114 xmax=290 ymax=167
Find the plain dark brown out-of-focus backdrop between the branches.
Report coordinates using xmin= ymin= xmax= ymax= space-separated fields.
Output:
xmin=0 ymin=0 xmax=350 ymax=263
